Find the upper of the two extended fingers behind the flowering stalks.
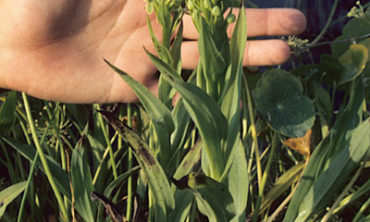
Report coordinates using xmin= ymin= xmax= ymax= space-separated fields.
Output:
xmin=183 ymin=8 xmax=306 ymax=39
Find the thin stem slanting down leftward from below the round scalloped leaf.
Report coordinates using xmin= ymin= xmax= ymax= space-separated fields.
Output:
xmin=252 ymin=132 xmax=278 ymax=222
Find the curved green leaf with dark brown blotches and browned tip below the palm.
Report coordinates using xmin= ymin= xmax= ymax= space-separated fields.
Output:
xmin=102 ymin=112 xmax=175 ymax=221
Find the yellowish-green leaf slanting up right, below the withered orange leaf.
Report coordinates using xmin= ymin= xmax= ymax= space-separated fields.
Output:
xmin=259 ymin=163 xmax=305 ymax=214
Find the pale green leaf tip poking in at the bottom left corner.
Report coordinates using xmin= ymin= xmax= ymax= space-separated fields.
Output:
xmin=0 ymin=181 xmax=27 ymax=219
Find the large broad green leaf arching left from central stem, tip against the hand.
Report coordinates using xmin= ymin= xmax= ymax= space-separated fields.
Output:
xmin=147 ymin=49 xmax=227 ymax=179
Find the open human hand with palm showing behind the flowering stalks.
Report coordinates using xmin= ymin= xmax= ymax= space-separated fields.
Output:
xmin=0 ymin=0 xmax=306 ymax=103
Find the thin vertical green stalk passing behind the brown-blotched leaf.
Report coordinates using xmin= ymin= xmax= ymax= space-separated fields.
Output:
xmin=126 ymin=104 xmax=133 ymax=221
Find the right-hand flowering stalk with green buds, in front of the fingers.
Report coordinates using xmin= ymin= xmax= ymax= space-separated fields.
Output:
xmin=186 ymin=0 xmax=235 ymax=100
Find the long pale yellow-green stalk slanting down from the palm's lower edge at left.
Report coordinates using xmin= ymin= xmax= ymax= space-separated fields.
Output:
xmin=22 ymin=93 xmax=68 ymax=221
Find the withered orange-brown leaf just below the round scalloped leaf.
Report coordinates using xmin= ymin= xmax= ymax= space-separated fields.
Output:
xmin=283 ymin=129 xmax=312 ymax=157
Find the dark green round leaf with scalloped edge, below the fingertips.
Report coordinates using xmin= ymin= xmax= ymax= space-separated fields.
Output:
xmin=253 ymin=70 xmax=315 ymax=137
